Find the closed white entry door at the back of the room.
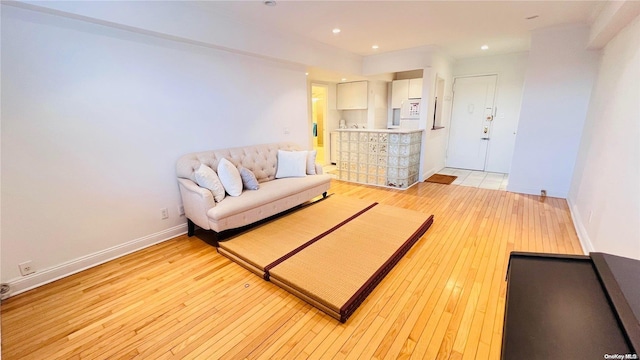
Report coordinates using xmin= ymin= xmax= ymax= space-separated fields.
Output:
xmin=447 ymin=75 xmax=497 ymax=170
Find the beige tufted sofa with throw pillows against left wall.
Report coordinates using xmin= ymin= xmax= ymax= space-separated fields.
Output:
xmin=176 ymin=143 xmax=331 ymax=240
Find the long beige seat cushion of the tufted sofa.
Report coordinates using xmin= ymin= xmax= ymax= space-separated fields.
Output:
xmin=207 ymin=175 xmax=331 ymax=220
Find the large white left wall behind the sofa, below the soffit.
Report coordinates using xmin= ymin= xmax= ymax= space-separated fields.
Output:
xmin=1 ymin=4 xmax=309 ymax=290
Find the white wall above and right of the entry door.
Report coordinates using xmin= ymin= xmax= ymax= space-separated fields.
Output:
xmin=453 ymin=52 xmax=528 ymax=173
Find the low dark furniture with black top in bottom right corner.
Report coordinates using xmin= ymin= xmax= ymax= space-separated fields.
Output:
xmin=502 ymin=252 xmax=640 ymax=359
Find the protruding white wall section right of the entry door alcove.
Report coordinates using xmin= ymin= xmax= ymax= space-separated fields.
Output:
xmin=507 ymin=26 xmax=599 ymax=198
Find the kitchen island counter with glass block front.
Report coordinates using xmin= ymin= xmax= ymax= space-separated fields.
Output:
xmin=337 ymin=129 xmax=423 ymax=189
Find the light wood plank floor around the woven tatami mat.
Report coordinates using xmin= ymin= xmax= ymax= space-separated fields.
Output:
xmin=2 ymin=180 xmax=581 ymax=360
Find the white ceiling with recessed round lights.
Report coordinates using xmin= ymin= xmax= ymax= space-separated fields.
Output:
xmin=198 ymin=0 xmax=605 ymax=59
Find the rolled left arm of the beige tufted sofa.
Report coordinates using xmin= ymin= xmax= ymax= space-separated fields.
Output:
xmin=178 ymin=178 xmax=216 ymax=230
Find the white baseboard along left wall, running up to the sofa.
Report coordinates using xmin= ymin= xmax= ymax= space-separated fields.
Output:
xmin=7 ymin=224 xmax=187 ymax=297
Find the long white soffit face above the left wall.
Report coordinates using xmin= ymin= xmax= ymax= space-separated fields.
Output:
xmin=12 ymin=1 xmax=362 ymax=74
